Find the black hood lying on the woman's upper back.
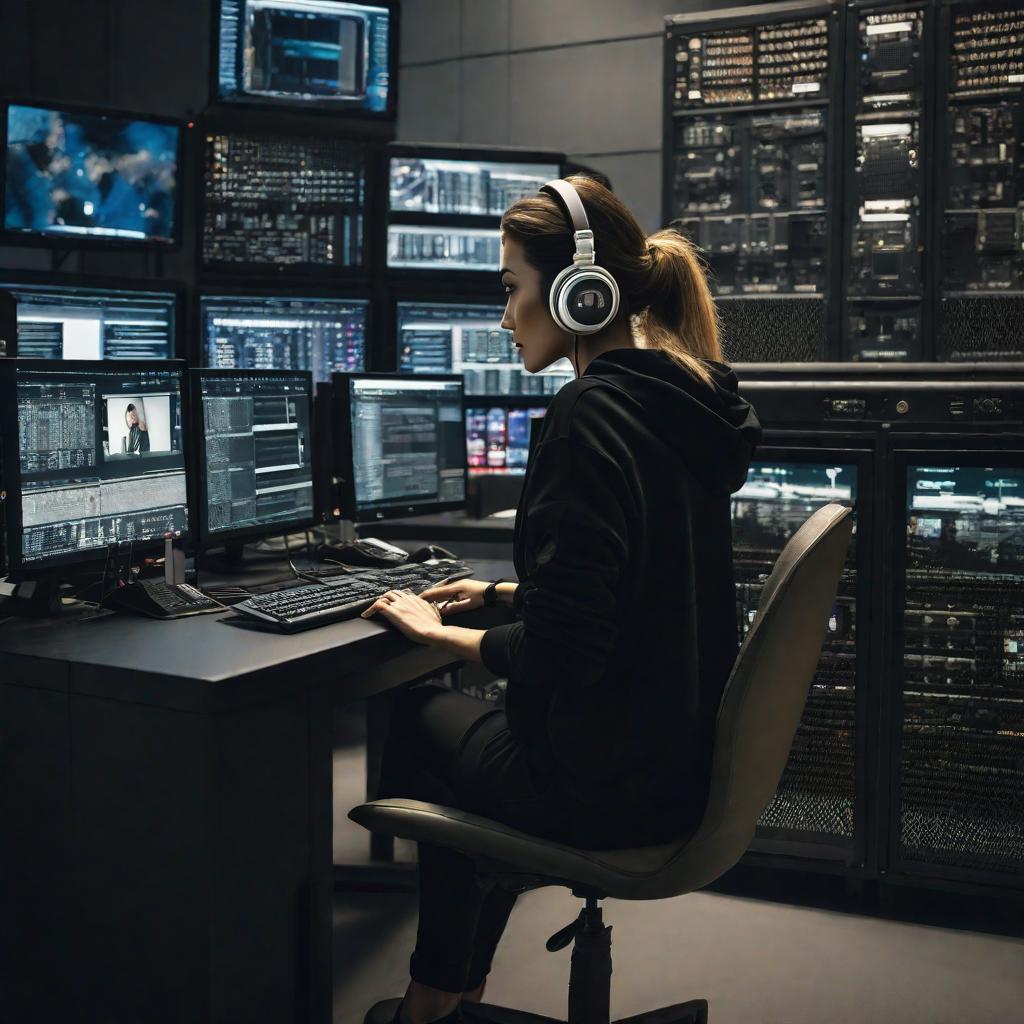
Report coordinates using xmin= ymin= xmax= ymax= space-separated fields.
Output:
xmin=583 ymin=348 xmax=761 ymax=495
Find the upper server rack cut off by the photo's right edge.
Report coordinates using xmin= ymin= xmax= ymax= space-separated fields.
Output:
xmin=933 ymin=0 xmax=1024 ymax=360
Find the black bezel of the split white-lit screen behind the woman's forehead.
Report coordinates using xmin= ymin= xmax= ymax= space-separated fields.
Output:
xmin=375 ymin=142 xmax=566 ymax=289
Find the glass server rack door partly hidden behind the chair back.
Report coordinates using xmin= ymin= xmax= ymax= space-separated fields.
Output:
xmin=732 ymin=442 xmax=872 ymax=866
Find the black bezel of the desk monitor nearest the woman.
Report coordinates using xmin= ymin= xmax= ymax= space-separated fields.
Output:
xmin=331 ymin=373 xmax=469 ymax=523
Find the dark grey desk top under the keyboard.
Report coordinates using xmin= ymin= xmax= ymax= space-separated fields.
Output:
xmin=0 ymin=560 xmax=514 ymax=713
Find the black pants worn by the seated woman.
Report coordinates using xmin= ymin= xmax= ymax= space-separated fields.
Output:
xmin=378 ymin=684 xmax=564 ymax=992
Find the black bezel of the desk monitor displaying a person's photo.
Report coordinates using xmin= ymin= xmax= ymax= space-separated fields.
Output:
xmin=0 ymin=358 xmax=197 ymax=579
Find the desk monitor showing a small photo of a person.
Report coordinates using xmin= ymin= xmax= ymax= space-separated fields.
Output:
xmin=0 ymin=359 xmax=189 ymax=574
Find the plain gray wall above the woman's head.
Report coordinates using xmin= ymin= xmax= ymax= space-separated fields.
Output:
xmin=398 ymin=0 xmax=765 ymax=231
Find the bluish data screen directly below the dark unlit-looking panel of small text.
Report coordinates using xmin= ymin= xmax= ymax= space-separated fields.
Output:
xmin=200 ymin=294 xmax=370 ymax=381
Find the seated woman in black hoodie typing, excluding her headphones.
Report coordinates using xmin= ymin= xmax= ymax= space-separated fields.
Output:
xmin=365 ymin=176 xmax=760 ymax=1024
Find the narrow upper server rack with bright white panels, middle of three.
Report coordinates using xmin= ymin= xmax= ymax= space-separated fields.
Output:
xmin=842 ymin=0 xmax=934 ymax=361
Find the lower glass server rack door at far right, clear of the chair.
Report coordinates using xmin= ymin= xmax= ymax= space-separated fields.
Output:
xmin=885 ymin=444 xmax=1024 ymax=886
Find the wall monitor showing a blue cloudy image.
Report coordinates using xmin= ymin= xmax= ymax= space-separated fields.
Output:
xmin=3 ymin=102 xmax=181 ymax=246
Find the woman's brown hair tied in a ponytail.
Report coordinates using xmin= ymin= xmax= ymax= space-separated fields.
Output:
xmin=502 ymin=174 xmax=723 ymax=384
